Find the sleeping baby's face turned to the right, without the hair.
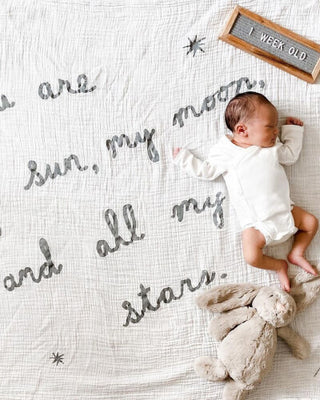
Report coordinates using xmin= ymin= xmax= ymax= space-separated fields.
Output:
xmin=244 ymin=104 xmax=279 ymax=147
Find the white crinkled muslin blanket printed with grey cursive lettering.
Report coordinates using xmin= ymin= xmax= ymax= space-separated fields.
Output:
xmin=0 ymin=0 xmax=320 ymax=400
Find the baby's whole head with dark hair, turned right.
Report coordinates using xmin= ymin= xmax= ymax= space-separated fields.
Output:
xmin=225 ymin=92 xmax=279 ymax=147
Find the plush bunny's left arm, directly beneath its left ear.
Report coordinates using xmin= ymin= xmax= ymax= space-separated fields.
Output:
xmin=209 ymin=307 xmax=256 ymax=341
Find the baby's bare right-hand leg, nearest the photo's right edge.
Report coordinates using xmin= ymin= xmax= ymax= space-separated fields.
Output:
xmin=288 ymin=206 xmax=318 ymax=275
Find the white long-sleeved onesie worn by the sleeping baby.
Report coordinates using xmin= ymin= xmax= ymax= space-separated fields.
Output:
xmin=174 ymin=125 xmax=303 ymax=245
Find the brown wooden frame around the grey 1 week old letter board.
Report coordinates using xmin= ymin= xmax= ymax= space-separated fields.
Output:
xmin=219 ymin=6 xmax=320 ymax=83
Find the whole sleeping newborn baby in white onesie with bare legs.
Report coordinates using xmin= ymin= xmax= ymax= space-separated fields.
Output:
xmin=173 ymin=92 xmax=318 ymax=292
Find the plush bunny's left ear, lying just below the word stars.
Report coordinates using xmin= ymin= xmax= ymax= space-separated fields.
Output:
xmin=196 ymin=283 xmax=260 ymax=312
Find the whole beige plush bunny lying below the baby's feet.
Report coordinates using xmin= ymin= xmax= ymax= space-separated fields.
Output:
xmin=194 ymin=271 xmax=320 ymax=400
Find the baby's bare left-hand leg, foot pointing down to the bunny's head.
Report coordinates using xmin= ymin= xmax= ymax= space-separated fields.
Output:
xmin=242 ymin=228 xmax=290 ymax=292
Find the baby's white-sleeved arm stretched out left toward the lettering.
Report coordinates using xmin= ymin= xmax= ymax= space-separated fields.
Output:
xmin=173 ymin=147 xmax=223 ymax=180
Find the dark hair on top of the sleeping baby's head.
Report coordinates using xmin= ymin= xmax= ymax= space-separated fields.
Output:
xmin=224 ymin=92 xmax=274 ymax=132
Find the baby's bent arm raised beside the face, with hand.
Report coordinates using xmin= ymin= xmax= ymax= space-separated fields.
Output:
xmin=278 ymin=117 xmax=303 ymax=165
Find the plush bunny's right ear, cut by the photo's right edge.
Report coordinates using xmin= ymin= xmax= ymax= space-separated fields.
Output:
xmin=289 ymin=268 xmax=320 ymax=312
